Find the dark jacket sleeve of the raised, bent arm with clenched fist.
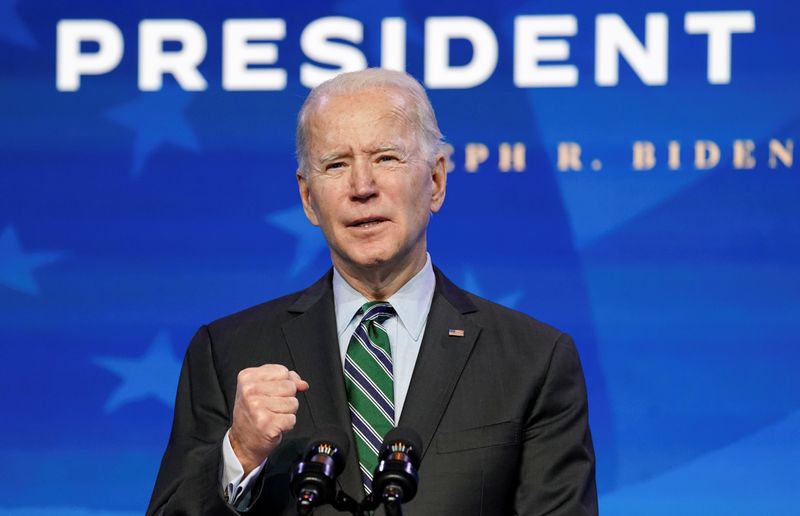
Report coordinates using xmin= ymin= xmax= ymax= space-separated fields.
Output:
xmin=147 ymin=326 xmax=242 ymax=516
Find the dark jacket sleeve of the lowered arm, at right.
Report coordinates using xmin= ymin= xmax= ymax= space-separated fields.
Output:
xmin=515 ymin=334 xmax=598 ymax=516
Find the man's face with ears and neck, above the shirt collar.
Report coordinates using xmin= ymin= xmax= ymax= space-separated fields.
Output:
xmin=297 ymin=88 xmax=446 ymax=276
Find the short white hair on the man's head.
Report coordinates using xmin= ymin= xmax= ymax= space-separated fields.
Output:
xmin=295 ymin=68 xmax=444 ymax=174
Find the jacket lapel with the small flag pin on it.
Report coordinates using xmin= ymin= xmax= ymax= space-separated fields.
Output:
xmin=398 ymin=268 xmax=481 ymax=457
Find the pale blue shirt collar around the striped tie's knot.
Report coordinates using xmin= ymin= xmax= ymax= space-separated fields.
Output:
xmin=333 ymin=253 xmax=436 ymax=340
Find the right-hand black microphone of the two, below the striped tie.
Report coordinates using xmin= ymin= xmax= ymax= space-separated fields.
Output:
xmin=371 ymin=428 xmax=422 ymax=515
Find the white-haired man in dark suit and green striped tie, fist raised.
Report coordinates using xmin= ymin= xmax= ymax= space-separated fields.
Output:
xmin=148 ymin=69 xmax=597 ymax=516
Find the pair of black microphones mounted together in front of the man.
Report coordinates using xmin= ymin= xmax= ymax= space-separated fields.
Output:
xmin=289 ymin=426 xmax=422 ymax=515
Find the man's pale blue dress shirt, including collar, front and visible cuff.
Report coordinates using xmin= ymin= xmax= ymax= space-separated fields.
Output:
xmin=222 ymin=255 xmax=436 ymax=510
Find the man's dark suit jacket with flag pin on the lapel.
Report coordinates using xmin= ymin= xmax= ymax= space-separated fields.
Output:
xmin=147 ymin=270 xmax=597 ymax=516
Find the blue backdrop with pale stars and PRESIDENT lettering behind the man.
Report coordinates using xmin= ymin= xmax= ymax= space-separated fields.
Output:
xmin=0 ymin=0 xmax=800 ymax=515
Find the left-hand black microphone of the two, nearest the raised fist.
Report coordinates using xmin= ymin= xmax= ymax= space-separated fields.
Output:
xmin=289 ymin=425 xmax=349 ymax=515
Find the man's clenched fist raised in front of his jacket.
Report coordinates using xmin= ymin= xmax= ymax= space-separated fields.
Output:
xmin=229 ymin=364 xmax=308 ymax=475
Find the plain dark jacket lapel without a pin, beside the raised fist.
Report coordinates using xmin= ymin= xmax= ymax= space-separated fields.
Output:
xmin=283 ymin=272 xmax=361 ymax=497
